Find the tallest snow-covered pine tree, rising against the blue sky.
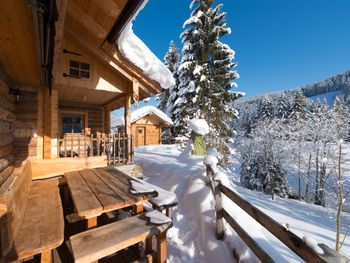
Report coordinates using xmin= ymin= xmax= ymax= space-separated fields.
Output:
xmin=174 ymin=0 xmax=241 ymax=161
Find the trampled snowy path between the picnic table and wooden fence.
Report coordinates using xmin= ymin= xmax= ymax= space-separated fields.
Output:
xmin=135 ymin=146 xmax=233 ymax=263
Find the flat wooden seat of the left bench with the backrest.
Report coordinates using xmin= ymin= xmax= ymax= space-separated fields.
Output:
xmin=7 ymin=180 xmax=64 ymax=260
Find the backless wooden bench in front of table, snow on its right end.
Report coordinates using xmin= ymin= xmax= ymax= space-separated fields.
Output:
xmin=70 ymin=211 xmax=172 ymax=263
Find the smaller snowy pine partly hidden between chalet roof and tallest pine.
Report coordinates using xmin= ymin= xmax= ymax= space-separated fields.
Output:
xmin=158 ymin=41 xmax=179 ymax=118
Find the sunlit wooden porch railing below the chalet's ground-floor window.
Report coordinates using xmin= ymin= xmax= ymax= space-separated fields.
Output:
xmin=58 ymin=132 xmax=134 ymax=165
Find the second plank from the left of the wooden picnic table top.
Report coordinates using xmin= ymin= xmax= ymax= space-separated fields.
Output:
xmin=79 ymin=169 xmax=125 ymax=211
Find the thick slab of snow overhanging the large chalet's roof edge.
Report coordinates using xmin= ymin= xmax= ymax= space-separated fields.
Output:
xmin=116 ymin=23 xmax=175 ymax=89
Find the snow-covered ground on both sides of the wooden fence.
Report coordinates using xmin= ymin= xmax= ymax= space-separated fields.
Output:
xmin=135 ymin=145 xmax=350 ymax=263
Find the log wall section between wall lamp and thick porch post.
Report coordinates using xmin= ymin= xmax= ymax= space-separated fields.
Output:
xmin=13 ymin=88 xmax=38 ymax=166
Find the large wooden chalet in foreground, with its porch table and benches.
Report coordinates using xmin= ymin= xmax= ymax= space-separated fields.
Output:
xmin=0 ymin=0 xmax=175 ymax=262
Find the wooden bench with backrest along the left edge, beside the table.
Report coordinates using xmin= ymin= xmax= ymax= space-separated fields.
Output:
xmin=0 ymin=162 xmax=64 ymax=262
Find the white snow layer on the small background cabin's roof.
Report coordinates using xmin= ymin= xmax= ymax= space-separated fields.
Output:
xmin=112 ymin=105 xmax=173 ymax=127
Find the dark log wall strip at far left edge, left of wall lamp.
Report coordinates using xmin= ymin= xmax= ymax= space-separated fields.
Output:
xmin=0 ymin=81 xmax=16 ymax=163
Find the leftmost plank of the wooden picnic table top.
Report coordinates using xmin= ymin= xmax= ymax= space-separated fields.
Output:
xmin=64 ymin=172 xmax=103 ymax=217
